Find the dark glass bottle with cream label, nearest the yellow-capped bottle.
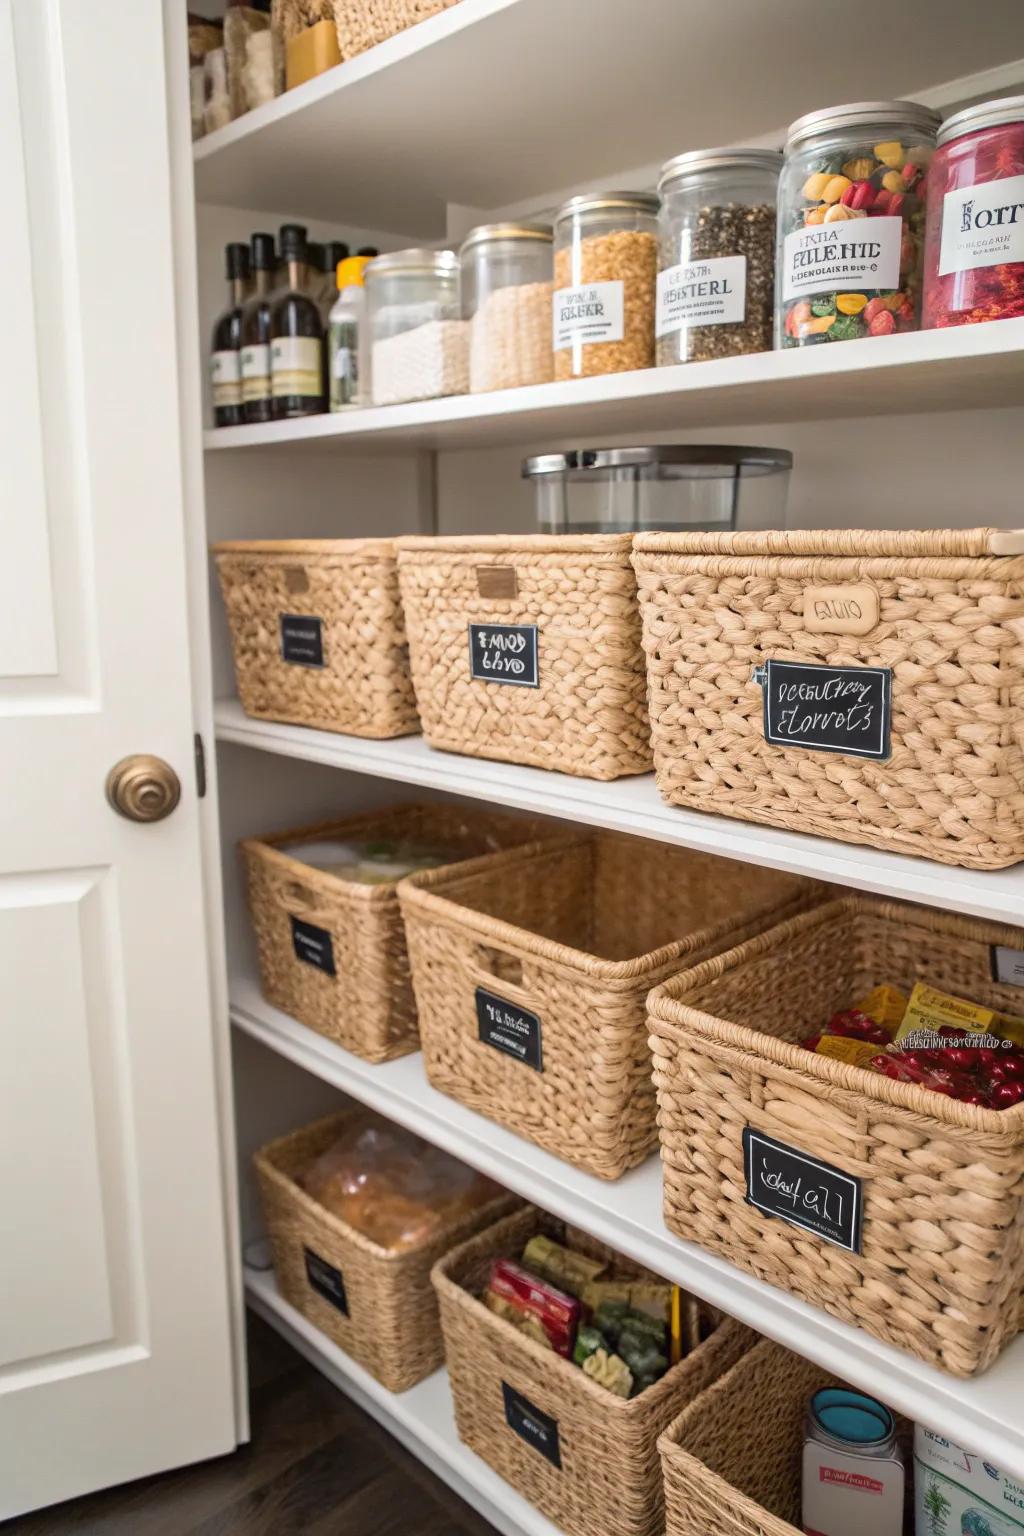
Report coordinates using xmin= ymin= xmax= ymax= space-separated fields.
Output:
xmin=270 ymin=224 xmax=325 ymax=421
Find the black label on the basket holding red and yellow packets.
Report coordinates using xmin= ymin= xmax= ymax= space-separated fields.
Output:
xmin=743 ymin=1126 xmax=863 ymax=1253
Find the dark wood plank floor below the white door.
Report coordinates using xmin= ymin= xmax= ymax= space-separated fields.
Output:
xmin=0 ymin=1313 xmax=494 ymax=1536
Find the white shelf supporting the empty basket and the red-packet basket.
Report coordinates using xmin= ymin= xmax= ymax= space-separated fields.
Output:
xmin=232 ymin=978 xmax=1024 ymax=1478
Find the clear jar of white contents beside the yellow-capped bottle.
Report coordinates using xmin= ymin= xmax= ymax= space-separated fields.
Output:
xmin=359 ymin=250 xmax=470 ymax=406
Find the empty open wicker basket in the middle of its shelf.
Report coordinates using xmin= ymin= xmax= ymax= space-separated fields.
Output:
xmin=399 ymin=833 xmax=814 ymax=1178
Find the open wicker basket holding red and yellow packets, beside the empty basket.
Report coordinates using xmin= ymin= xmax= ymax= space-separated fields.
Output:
xmin=649 ymin=897 xmax=1024 ymax=1376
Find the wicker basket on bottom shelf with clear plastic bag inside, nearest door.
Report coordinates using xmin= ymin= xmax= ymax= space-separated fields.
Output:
xmin=253 ymin=1111 xmax=519 ymax=1392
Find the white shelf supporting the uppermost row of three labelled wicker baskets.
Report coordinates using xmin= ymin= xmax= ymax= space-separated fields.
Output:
xmin=213 ymin=699 xmax=1024 ymax=925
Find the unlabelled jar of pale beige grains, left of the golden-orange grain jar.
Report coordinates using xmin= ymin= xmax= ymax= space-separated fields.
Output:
xmin=459 ymin=224 xmax=554 ymax=393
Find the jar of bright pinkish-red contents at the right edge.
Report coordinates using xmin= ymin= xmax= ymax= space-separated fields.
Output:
xmin=921 ymin=97 xmax=1024 ymax=330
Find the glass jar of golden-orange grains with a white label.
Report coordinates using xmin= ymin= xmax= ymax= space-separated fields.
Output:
xmin=553 ymin=192 xmax=657 ymax=379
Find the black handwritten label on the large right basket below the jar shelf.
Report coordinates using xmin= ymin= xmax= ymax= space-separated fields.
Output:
xmin=754 ymin=660 xmax=892 ymax=760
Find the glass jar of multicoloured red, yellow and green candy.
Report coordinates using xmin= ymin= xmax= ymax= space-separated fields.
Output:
xmin=775 ymin=101 xmax=940 ymax=347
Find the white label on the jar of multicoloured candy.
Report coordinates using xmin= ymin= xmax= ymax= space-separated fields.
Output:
xmin=783 ymin=214 xmax=903 ymax=300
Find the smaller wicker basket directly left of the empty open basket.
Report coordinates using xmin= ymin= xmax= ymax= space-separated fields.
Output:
xmin=241 ymin=805 xmax=537 ymax=1061
